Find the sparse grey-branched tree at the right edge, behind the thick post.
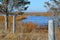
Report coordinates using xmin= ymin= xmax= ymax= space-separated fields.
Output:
xmin=45 ymin=0 xmax=60 ymax=25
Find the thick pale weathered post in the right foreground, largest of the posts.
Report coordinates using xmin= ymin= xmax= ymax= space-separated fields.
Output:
xmin=48 ymin=20 xmax=55 ymax=40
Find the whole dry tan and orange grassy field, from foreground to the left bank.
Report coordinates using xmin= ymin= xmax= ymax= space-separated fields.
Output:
xmin=0 ymin=14 xmax=60 ymax=40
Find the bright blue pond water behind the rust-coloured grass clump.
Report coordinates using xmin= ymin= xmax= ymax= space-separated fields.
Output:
xmin=22 ymin=16 xmax=49 ymax=25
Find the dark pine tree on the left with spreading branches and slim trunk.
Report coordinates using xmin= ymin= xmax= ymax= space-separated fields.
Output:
xmin=0 ymin=0 xmax=30 ymax=29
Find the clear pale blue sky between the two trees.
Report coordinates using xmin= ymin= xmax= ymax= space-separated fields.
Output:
xmin=26 ymin=0 xmax=48 ymax=12
